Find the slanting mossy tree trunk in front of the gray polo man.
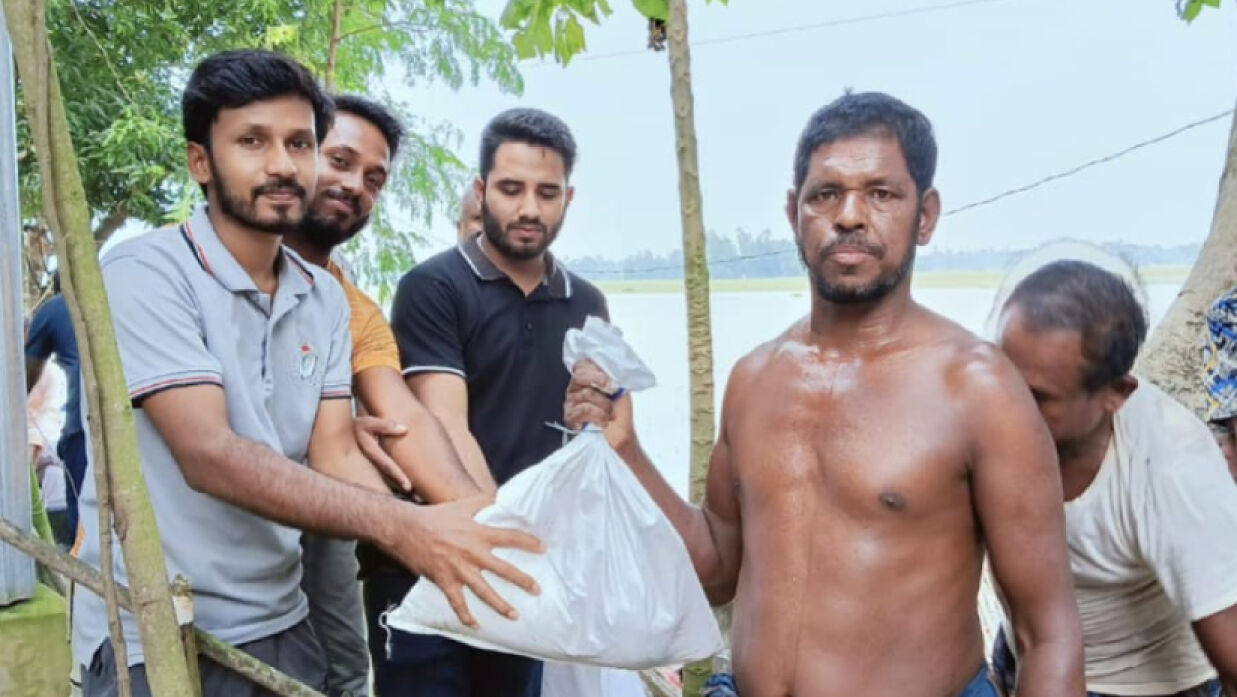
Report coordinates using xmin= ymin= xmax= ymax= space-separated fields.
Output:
xmin=4 ymin=0 xmax=193 ymax=697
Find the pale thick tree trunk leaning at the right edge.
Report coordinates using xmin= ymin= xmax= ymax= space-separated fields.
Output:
xmin=1134 ymin=98 xmax=1237 ymax=416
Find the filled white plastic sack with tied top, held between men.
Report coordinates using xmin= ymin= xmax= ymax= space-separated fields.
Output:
xmin=387 ymin=317 xmax=722 ymax=669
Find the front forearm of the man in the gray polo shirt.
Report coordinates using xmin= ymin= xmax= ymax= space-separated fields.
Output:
xmin=182 ymin=436 xmax=398 ymax=548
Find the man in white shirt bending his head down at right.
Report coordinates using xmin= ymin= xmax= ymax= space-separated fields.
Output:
xmin=996 ymin=261 xmax=1237 ymax=697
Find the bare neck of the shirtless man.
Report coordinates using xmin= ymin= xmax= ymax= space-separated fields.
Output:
xmin=810 ymin=281 xmax=915 ymax=353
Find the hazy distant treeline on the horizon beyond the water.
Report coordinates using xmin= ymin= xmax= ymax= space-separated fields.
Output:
xmin=565 ymin=230 xmax=1199 ymax=281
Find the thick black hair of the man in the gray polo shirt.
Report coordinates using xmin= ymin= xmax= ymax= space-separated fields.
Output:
xmin=181 ymin=48 xmax=335 ymax=150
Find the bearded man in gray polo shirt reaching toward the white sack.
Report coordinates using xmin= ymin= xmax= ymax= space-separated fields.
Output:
xmin=73 ymin=51 xmax=538 ymax=697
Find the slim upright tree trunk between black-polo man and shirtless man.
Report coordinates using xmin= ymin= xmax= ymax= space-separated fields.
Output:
xmin=667 ymin=0 xmax=725 ymax=697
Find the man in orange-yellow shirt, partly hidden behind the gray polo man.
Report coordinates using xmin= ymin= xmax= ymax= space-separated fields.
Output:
xmin=283 ymin=95 xmax=481 ymax=697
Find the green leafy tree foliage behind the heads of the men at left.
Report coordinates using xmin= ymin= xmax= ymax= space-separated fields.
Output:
xmin=19 ymin=0 xmax=523 ymax=296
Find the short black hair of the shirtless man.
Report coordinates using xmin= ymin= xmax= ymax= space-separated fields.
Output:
xmin=794 ymin=92 xmax=936 ymax=196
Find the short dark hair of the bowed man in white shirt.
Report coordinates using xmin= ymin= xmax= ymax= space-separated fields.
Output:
xmin=1006 ymin=260 xmax=1147 ymax=392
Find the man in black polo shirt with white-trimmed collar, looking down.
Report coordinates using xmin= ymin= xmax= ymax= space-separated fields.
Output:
xmin=362 ymin=109 xmax=609 ymax=697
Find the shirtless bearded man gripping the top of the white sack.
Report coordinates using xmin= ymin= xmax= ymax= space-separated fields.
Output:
xmin=567 ymin=93 xmax=1084 ymax=697
